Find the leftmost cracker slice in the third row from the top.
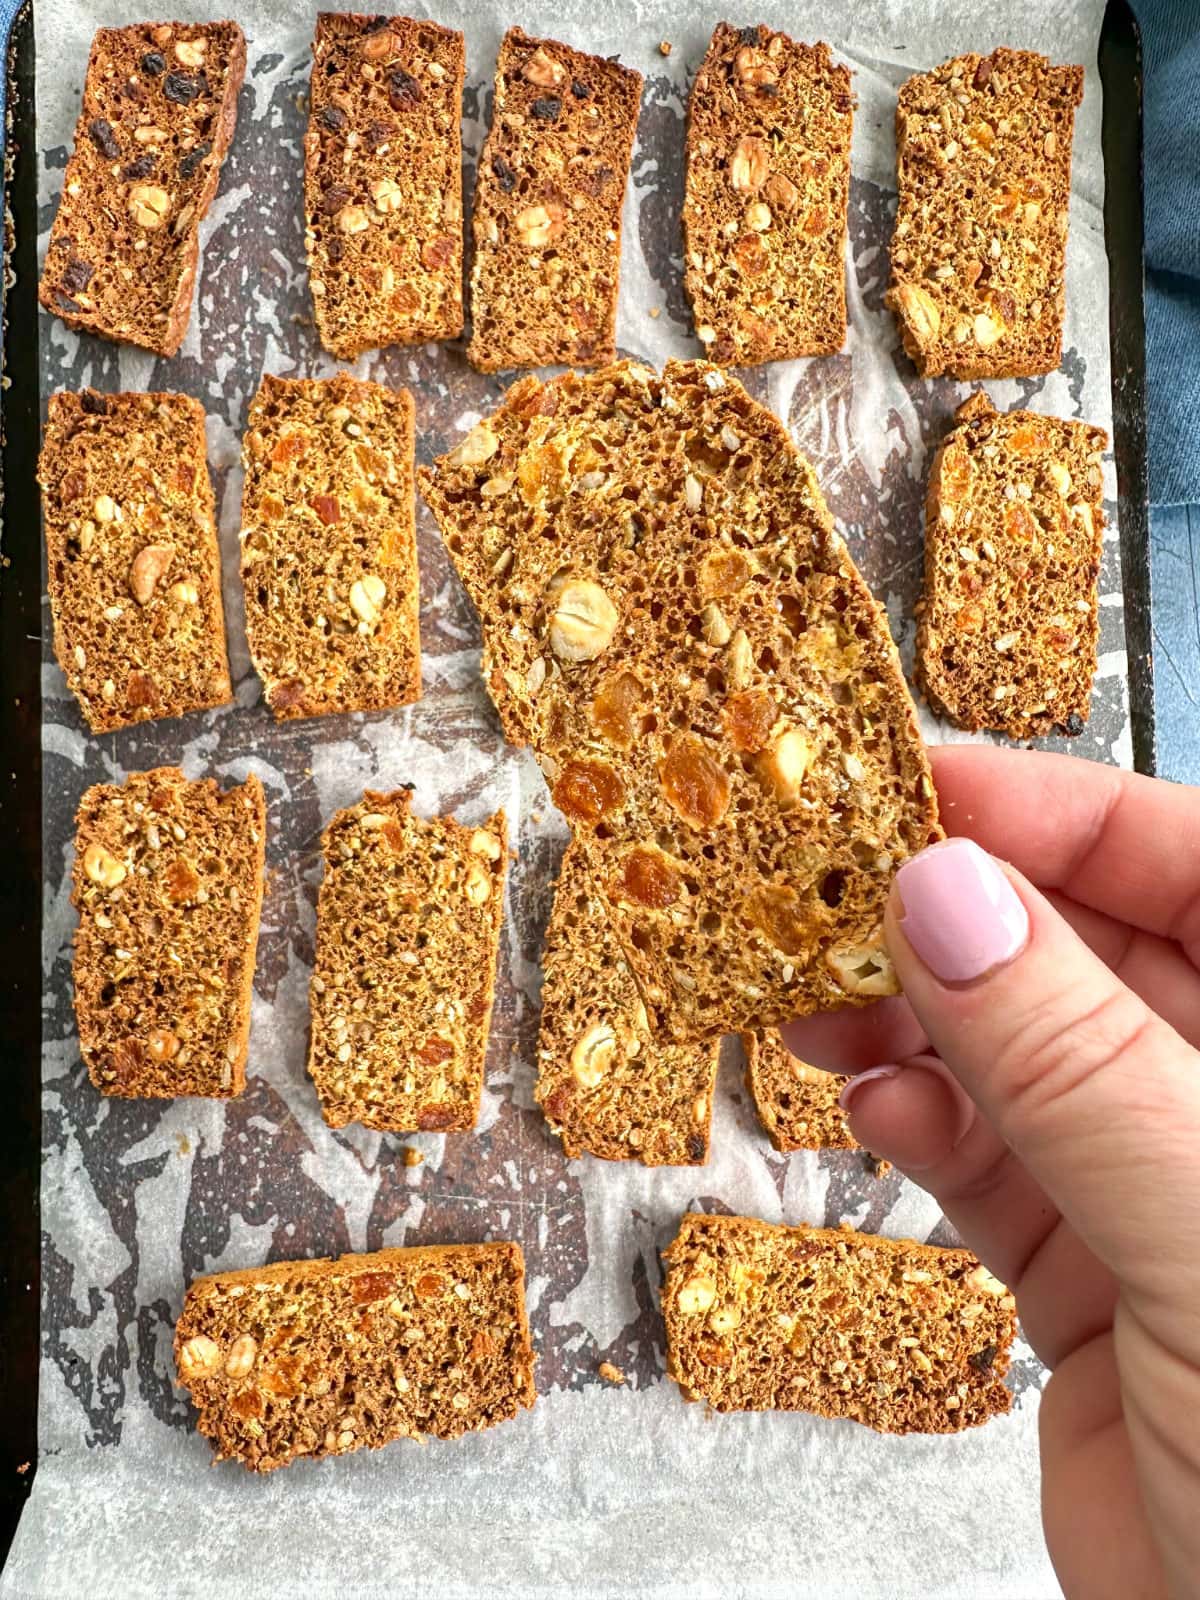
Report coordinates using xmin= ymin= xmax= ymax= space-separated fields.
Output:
xmin=70 ymin=766 xmax=266 ymax=1099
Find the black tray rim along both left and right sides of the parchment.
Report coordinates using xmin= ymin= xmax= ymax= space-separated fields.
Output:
xmin=0 ymin=0 xmax=1155 ymax=1570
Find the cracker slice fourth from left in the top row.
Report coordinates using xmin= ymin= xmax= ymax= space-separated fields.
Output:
xmin=683 ymin=22 xmax=854 ymax=366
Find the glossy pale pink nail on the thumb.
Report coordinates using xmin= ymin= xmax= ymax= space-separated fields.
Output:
xmin=896 ymin=838 xmax=1029 ymax=984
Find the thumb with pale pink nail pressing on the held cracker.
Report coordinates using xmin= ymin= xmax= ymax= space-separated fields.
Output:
xmin=885 ymin=838 xmax=1200 ymax=1342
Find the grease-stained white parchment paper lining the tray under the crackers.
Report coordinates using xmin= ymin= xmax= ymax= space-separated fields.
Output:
xmin=0 ymin=0 xmax=1131 ymax=1600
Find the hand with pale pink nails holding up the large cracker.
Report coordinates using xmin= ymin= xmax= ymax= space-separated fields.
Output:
xmin=781 ymin=746 xmax=1200 ymax=1600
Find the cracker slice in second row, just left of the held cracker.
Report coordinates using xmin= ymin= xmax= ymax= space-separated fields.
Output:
xmin=242 ymin=373 xmax=421 ymax=720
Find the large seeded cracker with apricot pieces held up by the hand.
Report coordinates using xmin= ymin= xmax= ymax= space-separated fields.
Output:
xmin=421 ymin=362 xmax=939 ymax=1040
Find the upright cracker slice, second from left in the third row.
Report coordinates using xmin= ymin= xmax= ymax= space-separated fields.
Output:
xmin=309 ymin=789 xmax=507 ymax=1133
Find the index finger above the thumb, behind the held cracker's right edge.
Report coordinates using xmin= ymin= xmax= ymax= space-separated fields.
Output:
xmin=930 ymin=744 xmax=1200 ymax=965
